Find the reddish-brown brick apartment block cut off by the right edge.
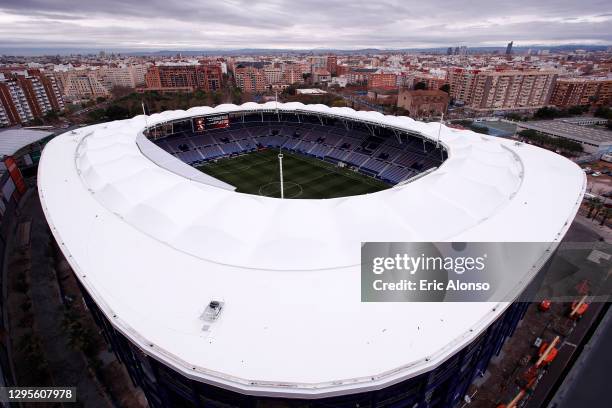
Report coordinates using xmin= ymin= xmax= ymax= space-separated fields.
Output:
xmin=550 ymin=77 xmax=612 ymax=108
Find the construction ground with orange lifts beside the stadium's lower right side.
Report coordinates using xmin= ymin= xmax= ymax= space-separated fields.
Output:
xmin=462 ymin=222 xmax=610 ymax=408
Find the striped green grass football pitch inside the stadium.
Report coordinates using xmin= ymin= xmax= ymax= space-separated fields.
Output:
xmin=198 ymin=149 xmax=391 ymax=199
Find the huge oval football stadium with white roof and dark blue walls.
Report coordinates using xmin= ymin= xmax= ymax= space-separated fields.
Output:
xmin=38 ymin=102 xmax=585 ymax=407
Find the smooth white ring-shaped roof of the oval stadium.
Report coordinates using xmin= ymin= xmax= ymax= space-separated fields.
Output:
xmin=38 ymin=102 xmax=585 ymax=398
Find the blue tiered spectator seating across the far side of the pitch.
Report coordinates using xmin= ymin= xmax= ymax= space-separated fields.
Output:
xmin=155 ymin=116 xmax=442 ymax=184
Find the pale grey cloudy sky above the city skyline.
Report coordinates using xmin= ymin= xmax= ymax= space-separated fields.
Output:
xmin=0 ymin=0 xmax=612 ymax=52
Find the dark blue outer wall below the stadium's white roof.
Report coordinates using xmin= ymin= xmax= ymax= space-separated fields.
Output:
xmin=81 ymin=282 xmax=529 ymax=408
